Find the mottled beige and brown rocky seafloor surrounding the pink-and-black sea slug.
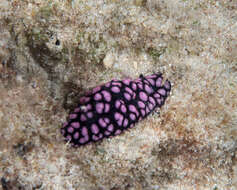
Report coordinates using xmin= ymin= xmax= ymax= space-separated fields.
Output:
xmin=0 ymin=0 xmax=237 ymax=190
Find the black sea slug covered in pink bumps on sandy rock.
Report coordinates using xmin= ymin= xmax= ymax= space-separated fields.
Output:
xmin=61 ymin=74 xmax=171 ymax=147
